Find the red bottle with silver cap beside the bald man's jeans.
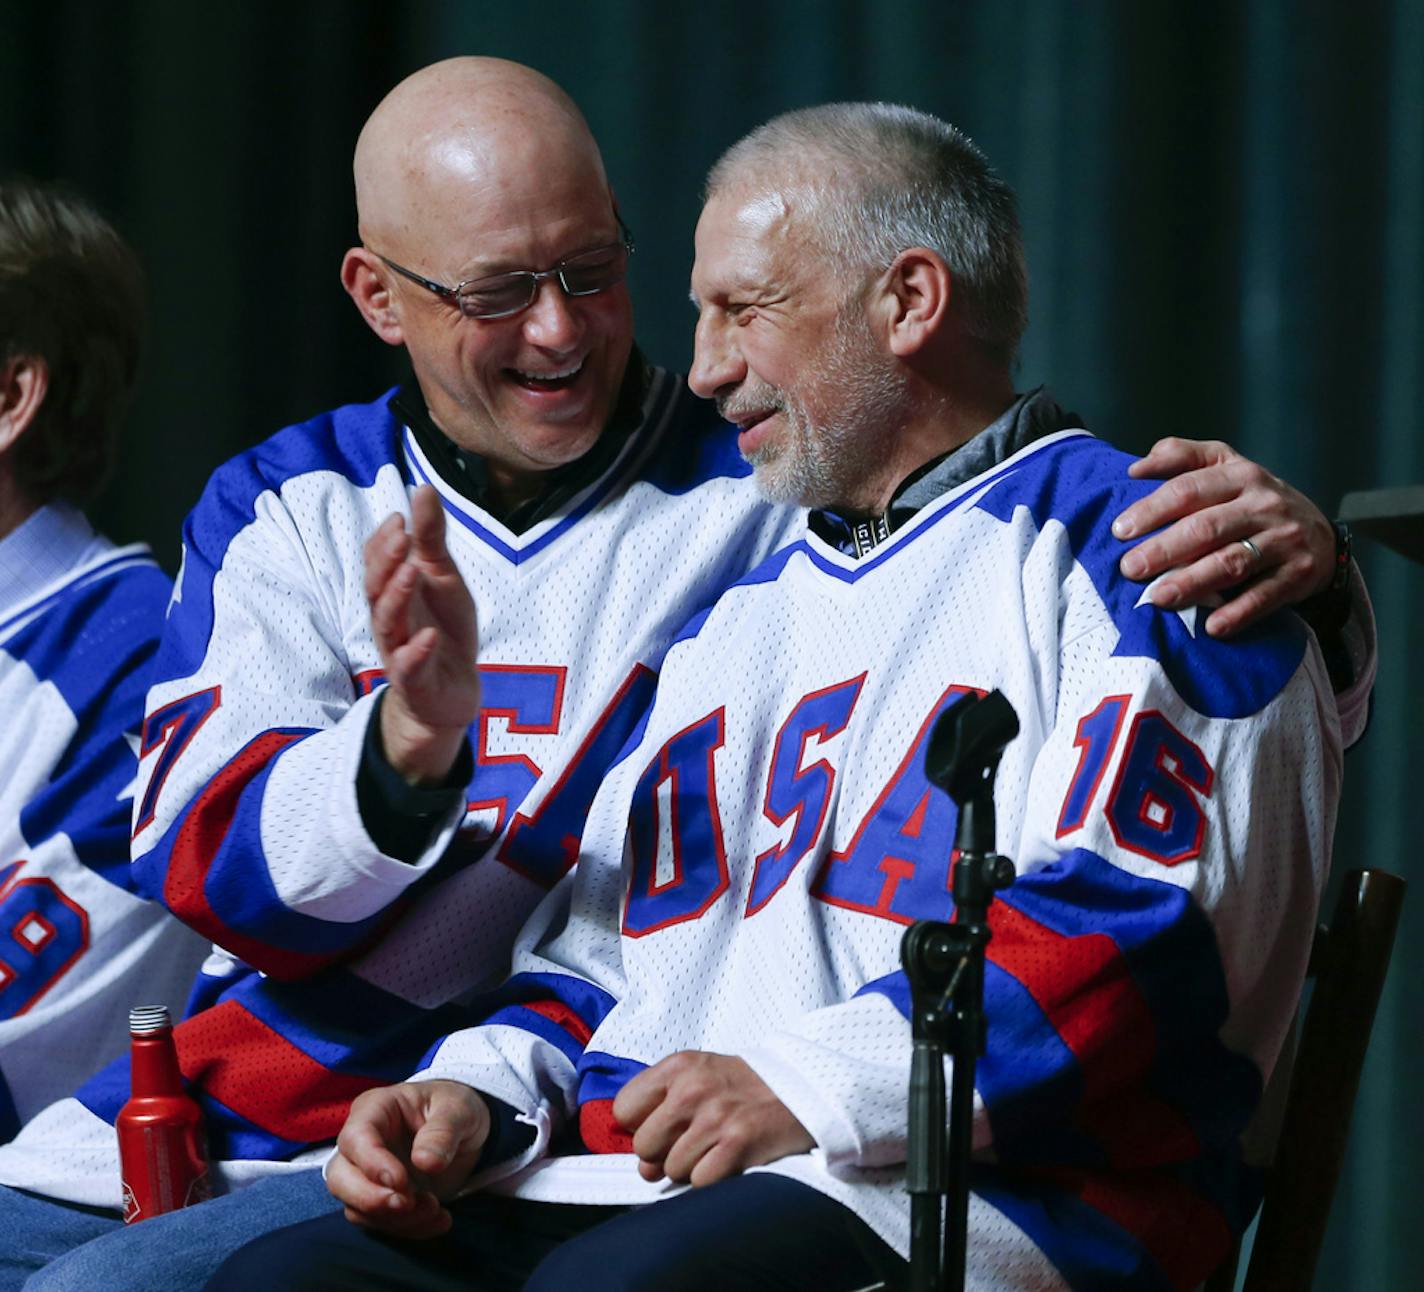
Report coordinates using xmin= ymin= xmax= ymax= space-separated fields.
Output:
xmin=114 ymin=1004 xmax=212 ymax=1224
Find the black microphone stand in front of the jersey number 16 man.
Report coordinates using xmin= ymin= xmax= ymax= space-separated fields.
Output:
xmin=900 ymin=691 xmax=1018 ymax=1292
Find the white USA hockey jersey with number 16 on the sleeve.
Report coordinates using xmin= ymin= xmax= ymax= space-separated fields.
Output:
xmin=422 ymin=433 xmax=1340 ymax=1289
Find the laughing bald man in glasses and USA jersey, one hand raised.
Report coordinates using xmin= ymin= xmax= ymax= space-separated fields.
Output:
xmin=0 ymin=58 xmax=1367 ymax=1289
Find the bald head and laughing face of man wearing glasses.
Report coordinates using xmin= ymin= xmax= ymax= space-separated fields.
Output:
xmin=342 ymin=58 xmax=632 ymax=506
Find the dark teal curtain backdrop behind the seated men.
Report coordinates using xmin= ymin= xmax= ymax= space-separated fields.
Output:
xmin=0 ymin=0 xmax=1424 ymax=1289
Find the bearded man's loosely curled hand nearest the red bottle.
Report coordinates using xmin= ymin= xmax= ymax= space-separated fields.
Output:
xmin=326 ymin=1081 xmax=490 ymax=1238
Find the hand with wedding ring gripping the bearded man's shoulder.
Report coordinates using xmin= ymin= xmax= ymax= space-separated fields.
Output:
xmin=1112 ymin=437 xmax=1336 ymax=637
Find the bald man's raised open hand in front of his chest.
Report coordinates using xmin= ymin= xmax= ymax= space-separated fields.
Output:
xmin=366 ymin=484 xmax=480 ymax=785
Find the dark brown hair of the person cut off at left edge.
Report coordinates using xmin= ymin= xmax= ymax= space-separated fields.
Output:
xmin=0 ymin=178 xmax=144 ymax=503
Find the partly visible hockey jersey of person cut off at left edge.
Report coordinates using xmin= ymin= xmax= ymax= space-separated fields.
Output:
xmin=0 ymin=504 xmax=202 ymax=1141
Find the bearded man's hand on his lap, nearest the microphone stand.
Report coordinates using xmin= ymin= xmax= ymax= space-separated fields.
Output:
xmin=614 ymin=1050 xmax=816 ymax=1185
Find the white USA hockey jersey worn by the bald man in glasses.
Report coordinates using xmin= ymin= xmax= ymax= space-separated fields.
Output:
xmin=0 ymin=372 xmax=799 ymax=1205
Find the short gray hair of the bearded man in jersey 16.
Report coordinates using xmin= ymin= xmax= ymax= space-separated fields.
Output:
xmin=703 ymin=103 xmax=1028 ymax=363
